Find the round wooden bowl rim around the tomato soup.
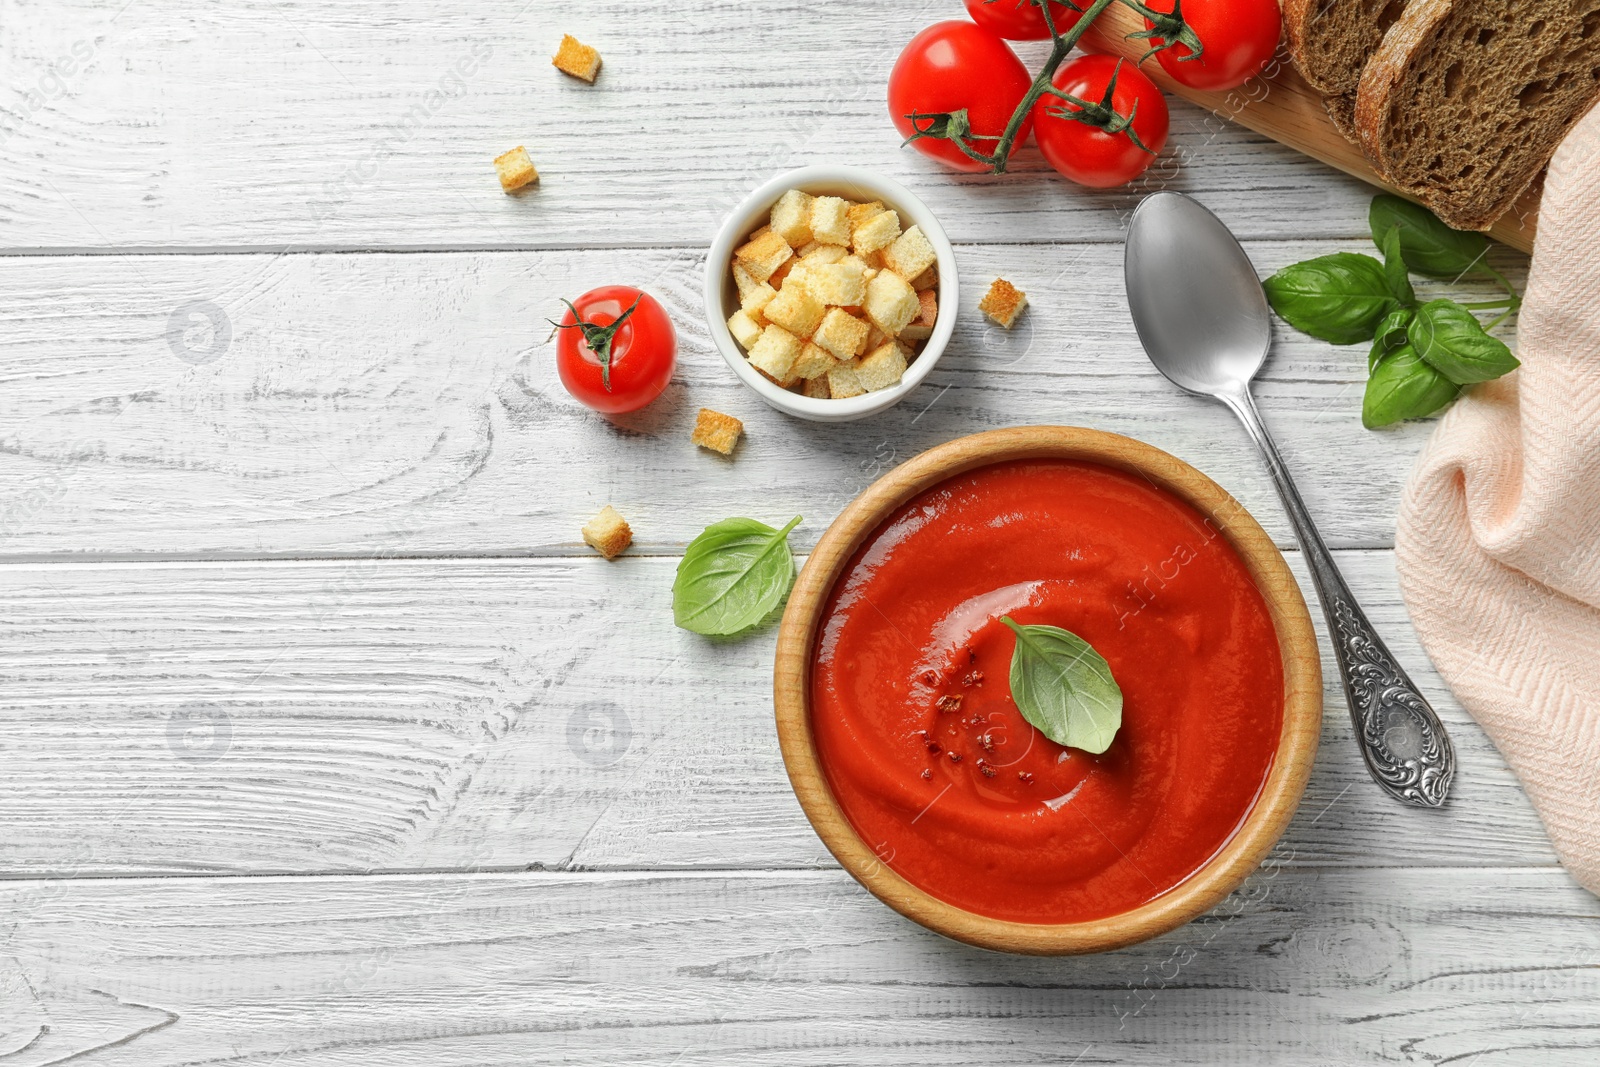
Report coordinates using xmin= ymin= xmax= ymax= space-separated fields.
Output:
xmin=773 ymin=426 xmax=1322 ymax=955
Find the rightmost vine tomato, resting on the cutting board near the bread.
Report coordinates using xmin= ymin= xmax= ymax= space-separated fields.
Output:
xmin=1144 ymin=0 xmax=1283 ymax=93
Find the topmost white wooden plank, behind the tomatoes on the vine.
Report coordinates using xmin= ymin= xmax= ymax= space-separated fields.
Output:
xmin=0 ymin=0 xmax=1401 ymax=253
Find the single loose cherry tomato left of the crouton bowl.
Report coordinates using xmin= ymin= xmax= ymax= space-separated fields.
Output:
xmin=555 ymin=285 xmax=678 ymax=414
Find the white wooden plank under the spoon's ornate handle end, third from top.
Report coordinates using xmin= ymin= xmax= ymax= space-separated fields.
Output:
xmin=0 ymin=552 xmax=1554 ymax=877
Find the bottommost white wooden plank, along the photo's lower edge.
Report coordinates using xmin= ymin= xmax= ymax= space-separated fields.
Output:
xmin=0 ymin=854 xmax=1600 ymax=1067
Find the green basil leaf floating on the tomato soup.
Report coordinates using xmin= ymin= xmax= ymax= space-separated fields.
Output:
xmin=1000 ymin=616 xmax=1122 ymax=755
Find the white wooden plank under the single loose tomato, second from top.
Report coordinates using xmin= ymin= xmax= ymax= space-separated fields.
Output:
xmin=0 ymin=241 xmax=1515 ymax=560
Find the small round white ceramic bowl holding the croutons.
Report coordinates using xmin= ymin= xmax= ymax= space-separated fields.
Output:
xmin=706 ymin=166 xmax=957 ymax=422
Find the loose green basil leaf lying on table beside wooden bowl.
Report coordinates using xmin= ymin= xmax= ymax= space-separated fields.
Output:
xmin=672 ymin=515 xmax=800 ymax=635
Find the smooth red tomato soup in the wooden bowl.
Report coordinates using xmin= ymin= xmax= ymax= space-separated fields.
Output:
xmin=811 ymin=461 xmax=1283 ymax=923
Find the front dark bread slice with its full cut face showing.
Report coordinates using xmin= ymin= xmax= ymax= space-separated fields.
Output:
xmin=1355 ymin=0 xmax=1600 ymax=230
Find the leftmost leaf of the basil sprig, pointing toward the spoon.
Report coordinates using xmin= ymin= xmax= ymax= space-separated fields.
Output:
xmin=1262 ymin=251 xmax=1395 ymax=344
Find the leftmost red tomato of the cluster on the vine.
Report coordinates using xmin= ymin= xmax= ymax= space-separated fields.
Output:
xmin=890 ymin=20 xmax=1034 ymax=171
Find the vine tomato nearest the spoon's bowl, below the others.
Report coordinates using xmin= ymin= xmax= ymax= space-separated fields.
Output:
xmin=1034 ymin=56 xmax=1168 ymax=189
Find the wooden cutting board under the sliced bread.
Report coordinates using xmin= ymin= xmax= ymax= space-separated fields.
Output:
xmin=1083 ymin=5 xmax=1539 ymax=253
